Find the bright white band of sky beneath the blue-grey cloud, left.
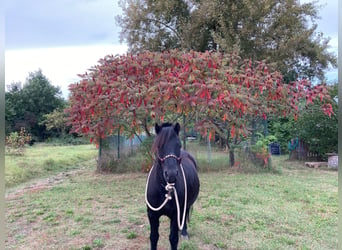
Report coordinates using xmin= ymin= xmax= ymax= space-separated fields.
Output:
xmin=5 ymin=45 xmax=127 ymax=99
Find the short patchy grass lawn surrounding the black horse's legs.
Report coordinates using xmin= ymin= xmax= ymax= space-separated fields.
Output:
xmin=5 ymin=145 xmax=338 ymax=250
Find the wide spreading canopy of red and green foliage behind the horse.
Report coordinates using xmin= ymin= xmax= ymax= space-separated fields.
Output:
xmin=67 ymin=50 xmax=332 ymax=166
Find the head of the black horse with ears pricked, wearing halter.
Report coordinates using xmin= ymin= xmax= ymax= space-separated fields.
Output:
xmin=153 ymin=123 xmax=181 ymax=183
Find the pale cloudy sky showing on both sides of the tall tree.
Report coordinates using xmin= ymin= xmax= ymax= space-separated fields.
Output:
xmin=5 ymin=0 xmax=338 ymax=99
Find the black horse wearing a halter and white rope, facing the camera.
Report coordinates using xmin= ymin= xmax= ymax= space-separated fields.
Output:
xmin=145 ymin=123 xmax=200 ymax=250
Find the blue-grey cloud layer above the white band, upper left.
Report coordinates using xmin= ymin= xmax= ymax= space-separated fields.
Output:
xmin=5 ymin=0 xmax=121 ymax=49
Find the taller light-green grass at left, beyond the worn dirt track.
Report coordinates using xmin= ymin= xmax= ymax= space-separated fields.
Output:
xmin=5 ymin=144 xmax=97 ymax=187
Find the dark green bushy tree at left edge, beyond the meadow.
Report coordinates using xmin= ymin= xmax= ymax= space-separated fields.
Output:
xmin=5 ymin=69 xmax=65 ymax=140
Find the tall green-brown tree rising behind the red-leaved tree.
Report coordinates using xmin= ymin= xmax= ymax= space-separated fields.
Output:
xmin=117 ymin=0 xmax=336 ymax=82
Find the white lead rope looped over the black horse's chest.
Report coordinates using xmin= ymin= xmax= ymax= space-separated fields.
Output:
xmin=145 ymin=163 xmax=188 ymax=230
